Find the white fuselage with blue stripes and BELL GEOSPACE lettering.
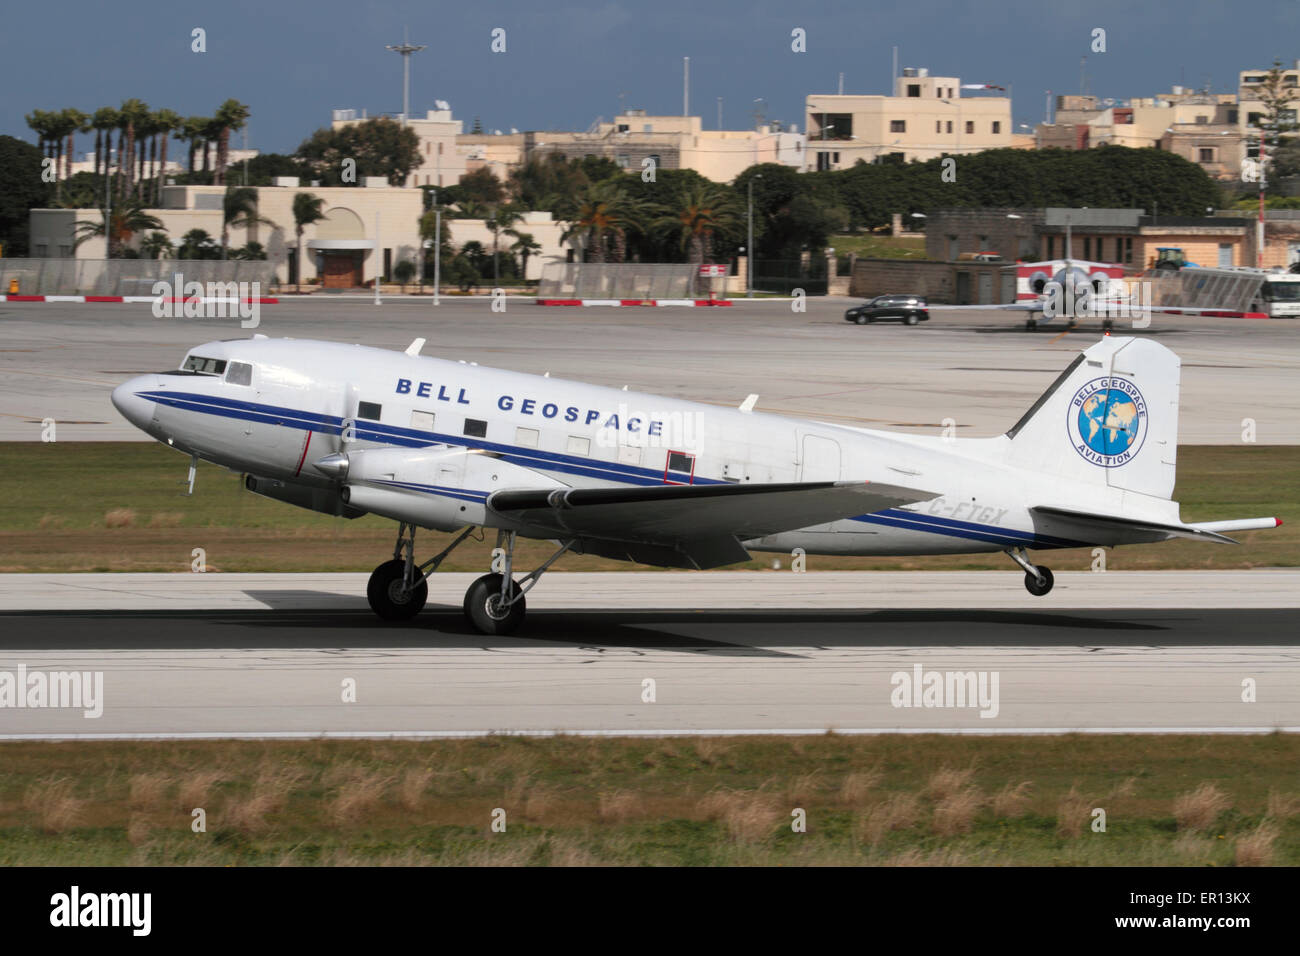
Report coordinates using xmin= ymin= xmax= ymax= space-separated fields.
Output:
xmin=113 ymin=338 xmax=1177 ymax=555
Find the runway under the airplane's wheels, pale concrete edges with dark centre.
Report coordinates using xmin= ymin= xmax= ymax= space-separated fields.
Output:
xmin=0 ymin=570 xmax=1300 ymax=739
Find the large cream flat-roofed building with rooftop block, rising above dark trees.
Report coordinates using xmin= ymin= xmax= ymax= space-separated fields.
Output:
xmin=803 ymin=68 xmax=1013 ymax=170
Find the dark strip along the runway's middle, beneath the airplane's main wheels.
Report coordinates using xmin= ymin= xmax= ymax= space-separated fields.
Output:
xmin=0 ymin=606 xmax=1284 ymax=658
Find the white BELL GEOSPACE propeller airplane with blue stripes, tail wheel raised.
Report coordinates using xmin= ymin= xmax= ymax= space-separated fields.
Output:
xmin=112 ymin=334 xmax=1281 ymax=635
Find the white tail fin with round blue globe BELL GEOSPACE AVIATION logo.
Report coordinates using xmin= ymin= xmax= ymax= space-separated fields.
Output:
xmin=1006 ymin=336 xmax=1180 ymax=498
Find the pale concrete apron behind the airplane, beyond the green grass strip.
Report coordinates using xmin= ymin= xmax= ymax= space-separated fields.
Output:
xmin=0 ymin=295 xmax=1300 ymax=445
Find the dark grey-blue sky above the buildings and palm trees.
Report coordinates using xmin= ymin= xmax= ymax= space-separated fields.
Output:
xmin=0 ymin=0 xmax=1300 ymax=152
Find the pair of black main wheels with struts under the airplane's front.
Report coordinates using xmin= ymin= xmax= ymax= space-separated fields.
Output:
xmin=365 ymin=522 xmax=575 ymax=635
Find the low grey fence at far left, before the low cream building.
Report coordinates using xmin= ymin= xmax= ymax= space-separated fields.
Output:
xmin=0 ymin=259 xmax=274 ymax=295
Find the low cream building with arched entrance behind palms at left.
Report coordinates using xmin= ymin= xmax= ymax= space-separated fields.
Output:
xmin=30 ymin=177 xmax=424 ymax=287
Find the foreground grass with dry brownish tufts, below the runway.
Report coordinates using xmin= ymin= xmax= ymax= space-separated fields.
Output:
xmin=0 ymin=734 xmax=1300 ymax=866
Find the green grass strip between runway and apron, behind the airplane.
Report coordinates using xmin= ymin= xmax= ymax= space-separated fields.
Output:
xmin=0 ymin=442 xmax=1300 ymax=572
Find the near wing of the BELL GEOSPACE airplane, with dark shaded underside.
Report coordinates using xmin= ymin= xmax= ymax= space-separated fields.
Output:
xmin=488 ymin=481 xmax=937 ymax=567
